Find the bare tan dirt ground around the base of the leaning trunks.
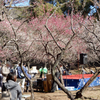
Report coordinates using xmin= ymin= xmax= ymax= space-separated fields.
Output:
xmin=24 ymin=86 xmax=100 ymax=100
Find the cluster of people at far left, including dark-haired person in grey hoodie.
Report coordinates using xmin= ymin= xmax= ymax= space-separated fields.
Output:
xmin=0 ymin=63 xmax=32 ymax=100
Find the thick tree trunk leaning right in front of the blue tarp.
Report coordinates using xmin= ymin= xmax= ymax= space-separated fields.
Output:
xmin=75 ymin=69 xmax=100 ymax=98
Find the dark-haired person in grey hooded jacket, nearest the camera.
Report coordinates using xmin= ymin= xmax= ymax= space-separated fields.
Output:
xmin=4 ymin=73 xmax=22 ymax=100
